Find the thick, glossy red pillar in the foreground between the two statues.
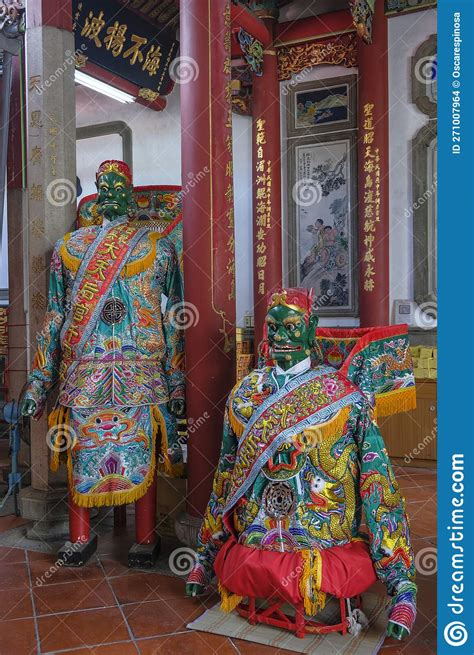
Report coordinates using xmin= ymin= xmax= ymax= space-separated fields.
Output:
xmin=180 ymin=0 xmax=235 ymax=517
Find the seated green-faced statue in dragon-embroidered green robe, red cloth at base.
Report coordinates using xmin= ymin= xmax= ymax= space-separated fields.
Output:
xmin=186 ymin=289 xmax=417 ymax=639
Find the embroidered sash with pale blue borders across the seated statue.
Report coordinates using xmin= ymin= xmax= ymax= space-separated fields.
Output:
xmin=224 ymin=366 xmax=361 ymax=515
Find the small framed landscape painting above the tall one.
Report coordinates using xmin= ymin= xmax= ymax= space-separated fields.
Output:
xmin=287 ymin=75 xmax=357 ymax=136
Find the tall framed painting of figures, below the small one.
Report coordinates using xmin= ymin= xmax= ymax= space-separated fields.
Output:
xmin=288 ymin=131 xmax=358 ymax=316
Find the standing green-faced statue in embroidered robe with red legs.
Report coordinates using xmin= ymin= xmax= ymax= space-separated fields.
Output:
xmin=21 ymin=160 xmax=185 ymax=566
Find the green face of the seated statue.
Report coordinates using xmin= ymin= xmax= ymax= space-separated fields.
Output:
xmin=267 ymin=305 xmax=318 ymax=368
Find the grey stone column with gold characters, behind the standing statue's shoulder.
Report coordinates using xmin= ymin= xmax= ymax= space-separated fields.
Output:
xmin=21 ymin=0 xmax=76 ymax=539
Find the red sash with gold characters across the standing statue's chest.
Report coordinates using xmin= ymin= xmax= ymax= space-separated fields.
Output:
xmin=60 ymin=218 xmax=149 ymax=380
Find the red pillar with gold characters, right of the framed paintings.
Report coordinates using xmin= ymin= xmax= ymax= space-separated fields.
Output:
xmin=357 ymin=2 xmax=390 ymax=327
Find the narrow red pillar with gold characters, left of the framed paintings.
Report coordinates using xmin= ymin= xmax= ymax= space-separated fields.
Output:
xmin=252 ymin=11 xmax=282 ymax=344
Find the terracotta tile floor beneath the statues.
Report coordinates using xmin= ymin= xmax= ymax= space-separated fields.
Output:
xmin=0 ymin=467 xmax=436 ymax=655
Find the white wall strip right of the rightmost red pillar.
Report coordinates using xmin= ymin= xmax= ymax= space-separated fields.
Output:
xmin=388 ymin=9 xmax=437 ymax=312
